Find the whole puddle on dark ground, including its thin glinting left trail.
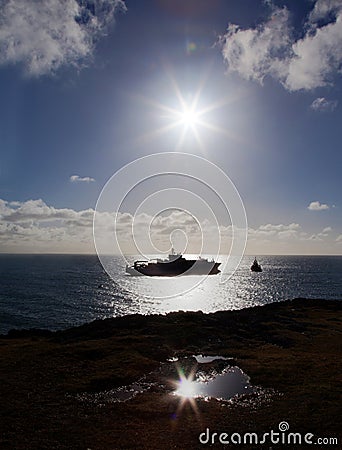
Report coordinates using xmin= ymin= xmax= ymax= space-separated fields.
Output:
xmin=77 ymin=354 xmax=270 ymax=406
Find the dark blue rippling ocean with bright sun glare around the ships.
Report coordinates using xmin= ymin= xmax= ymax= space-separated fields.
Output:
xmin=0 ymin=254 xmax=342 ymax=334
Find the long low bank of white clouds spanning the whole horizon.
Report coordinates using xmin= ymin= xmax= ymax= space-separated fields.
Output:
xmin=0 ymin=199 xmax=342 ymax=254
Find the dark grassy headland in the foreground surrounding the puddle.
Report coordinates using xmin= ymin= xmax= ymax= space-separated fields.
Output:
xmin=0 ymin=299 xmax=342 ymax=449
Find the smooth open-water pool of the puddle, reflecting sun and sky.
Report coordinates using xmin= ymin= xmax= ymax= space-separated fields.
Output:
xmin=174 ymin=366 xmax=256 ymax=400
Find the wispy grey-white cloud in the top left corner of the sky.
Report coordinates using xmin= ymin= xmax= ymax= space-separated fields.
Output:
xmin=0 ymin=0 xmax=125 ymax=76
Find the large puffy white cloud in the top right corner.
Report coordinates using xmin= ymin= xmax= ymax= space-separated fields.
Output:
xmin=222 ymin=0 xmax=342 ymax=91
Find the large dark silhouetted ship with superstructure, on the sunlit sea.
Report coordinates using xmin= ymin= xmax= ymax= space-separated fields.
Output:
xmin=126 ymin=249 xmax=221 ymax=277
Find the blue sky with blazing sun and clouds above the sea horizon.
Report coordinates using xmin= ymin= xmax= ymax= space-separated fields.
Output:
xmin=0 ymin=0 xmax=342 ymax=255
